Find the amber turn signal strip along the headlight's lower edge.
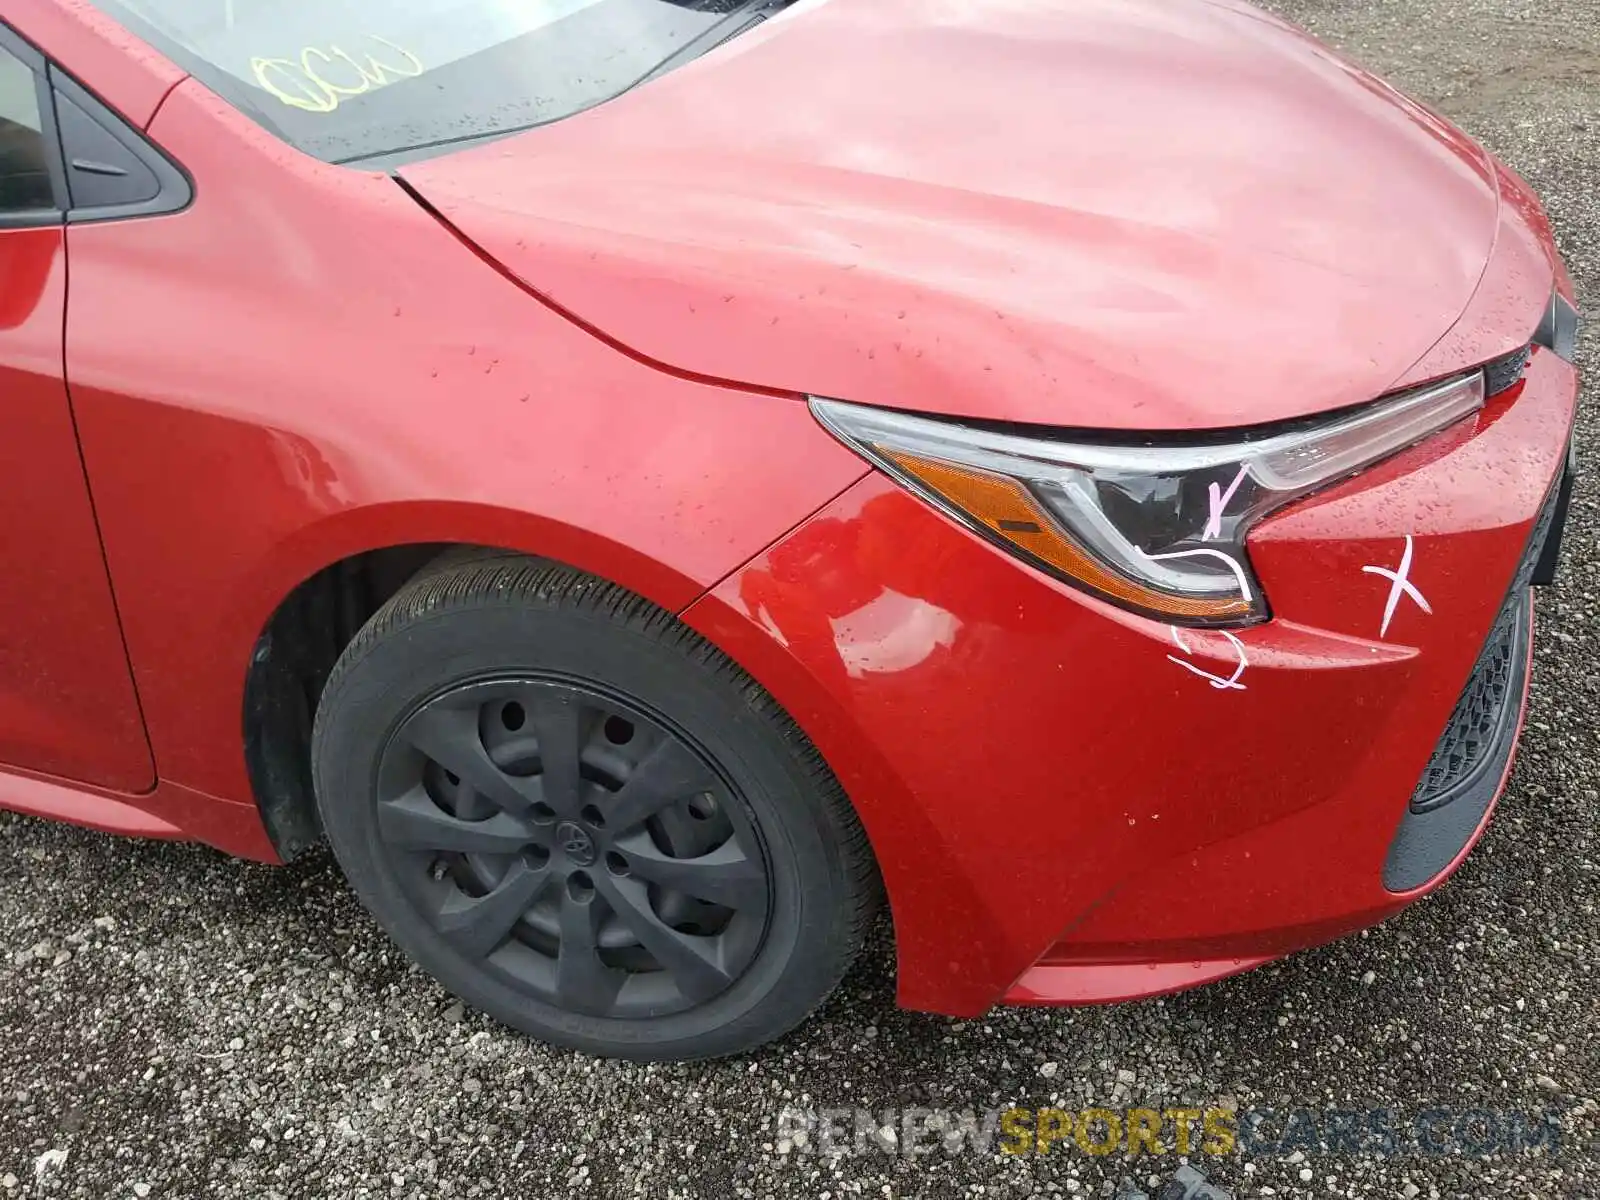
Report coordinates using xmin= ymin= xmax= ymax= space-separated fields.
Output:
xmin=874 ymin=445 xmax=1251 ymax=621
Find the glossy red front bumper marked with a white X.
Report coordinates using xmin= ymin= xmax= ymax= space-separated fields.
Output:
xmin=686 ymin=347 xmax=1576 ymax=1014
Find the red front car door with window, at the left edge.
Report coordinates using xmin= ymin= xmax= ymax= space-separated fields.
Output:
xmin=0 ymin=24 xmax=155 ymax=792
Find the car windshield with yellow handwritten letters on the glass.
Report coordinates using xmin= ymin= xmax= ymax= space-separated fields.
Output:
xmin=91 ymin=0 xmax=784 ymax=162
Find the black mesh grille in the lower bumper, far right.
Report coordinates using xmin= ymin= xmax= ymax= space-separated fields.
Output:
xmin=1411 ymin=488 xmax=1560 ymax=813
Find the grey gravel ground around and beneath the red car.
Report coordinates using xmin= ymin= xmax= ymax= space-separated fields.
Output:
xmin=0 ymin=0 xmax=1600 ymax=1198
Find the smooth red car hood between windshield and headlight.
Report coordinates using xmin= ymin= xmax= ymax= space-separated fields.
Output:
xmin=402 ymin=0 xmax=1498 ymax=429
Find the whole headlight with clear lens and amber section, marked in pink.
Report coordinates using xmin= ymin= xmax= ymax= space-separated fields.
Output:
xmin=811 ymin=371 xmax=1483 ymax=626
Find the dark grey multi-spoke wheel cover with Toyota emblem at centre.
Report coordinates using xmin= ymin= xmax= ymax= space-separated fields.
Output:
xmin=376 ymin=675 xmax=773 ymax=1018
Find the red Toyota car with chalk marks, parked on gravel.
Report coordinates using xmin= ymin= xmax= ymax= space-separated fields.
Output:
xmin=0 ymin=0 xmax=1578 ymax=1059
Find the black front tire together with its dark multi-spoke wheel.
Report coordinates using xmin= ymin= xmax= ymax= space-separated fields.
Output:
xmin=312 ymin=557 xmax=878 ymax=1061
